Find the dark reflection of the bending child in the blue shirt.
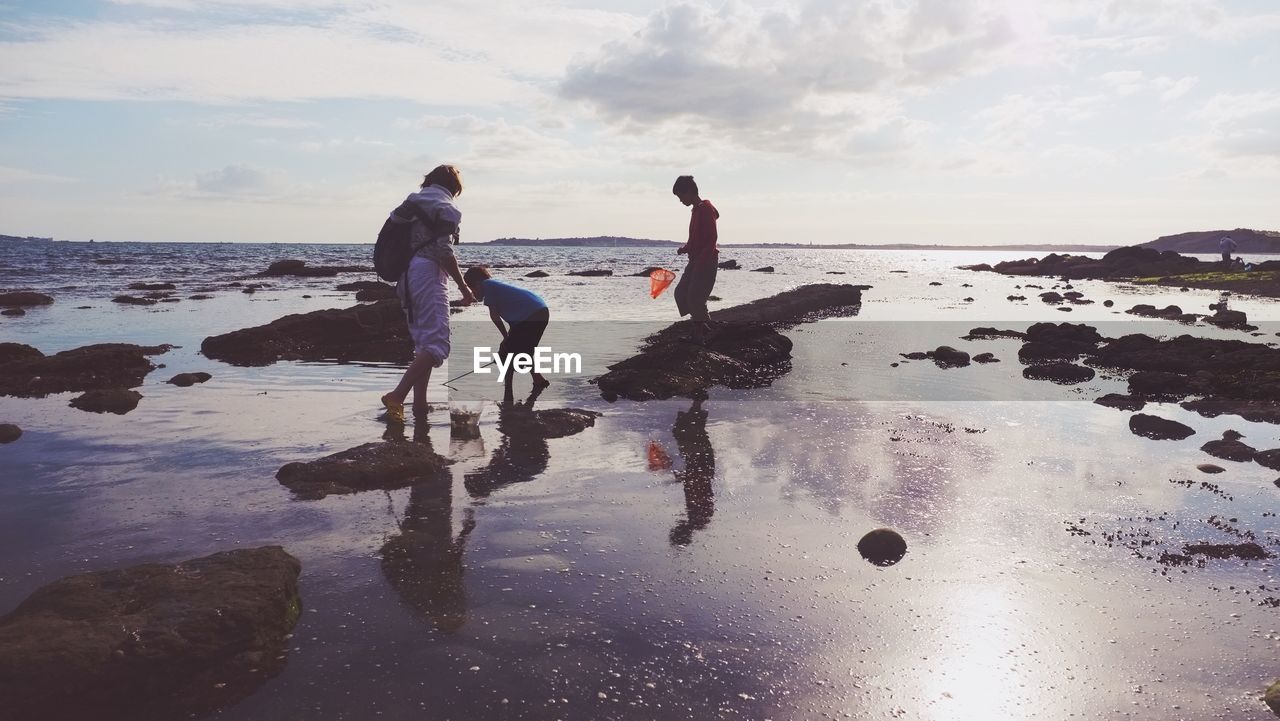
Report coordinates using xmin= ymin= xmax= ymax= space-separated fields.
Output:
xmin=463 ymin=385 xmax=552 ymax=498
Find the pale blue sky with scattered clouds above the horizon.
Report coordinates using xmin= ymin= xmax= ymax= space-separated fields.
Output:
xmin=0 ymin=0 xmax=1280 ymax=245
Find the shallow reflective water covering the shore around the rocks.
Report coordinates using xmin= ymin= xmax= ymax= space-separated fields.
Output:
xmin=0 ymin=243 xmax=1280 ymax=720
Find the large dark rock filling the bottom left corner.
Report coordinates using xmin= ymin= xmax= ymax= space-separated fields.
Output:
xmin=0 ymin=546 xmax=302 ymax=721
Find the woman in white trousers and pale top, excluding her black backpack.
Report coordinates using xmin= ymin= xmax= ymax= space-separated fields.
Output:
xmin=383 ymin=165 xmax=475 ymax=423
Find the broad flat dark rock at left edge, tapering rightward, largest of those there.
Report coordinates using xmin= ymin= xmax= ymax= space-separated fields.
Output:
xmin=0 ymin=343 xmax=169 ymax=398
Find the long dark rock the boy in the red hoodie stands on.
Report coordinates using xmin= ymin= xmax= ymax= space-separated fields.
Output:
xmin=594 ymin=283 xmax=868 ymax=401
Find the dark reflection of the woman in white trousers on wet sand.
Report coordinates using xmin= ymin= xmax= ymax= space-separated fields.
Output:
xmin=381 ymin=426 xmax=476 ymax=633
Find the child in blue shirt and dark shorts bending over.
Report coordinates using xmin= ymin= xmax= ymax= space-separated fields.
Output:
xmin=462 ymin=265 xmax=550 ymax=403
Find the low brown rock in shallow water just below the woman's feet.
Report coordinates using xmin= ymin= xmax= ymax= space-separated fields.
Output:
xmin=275 ymin=441 xmax=453 ymax=499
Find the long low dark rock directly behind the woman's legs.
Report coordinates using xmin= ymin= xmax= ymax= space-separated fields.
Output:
xmin=200 ymin=300 xmax=413 ymax=365
